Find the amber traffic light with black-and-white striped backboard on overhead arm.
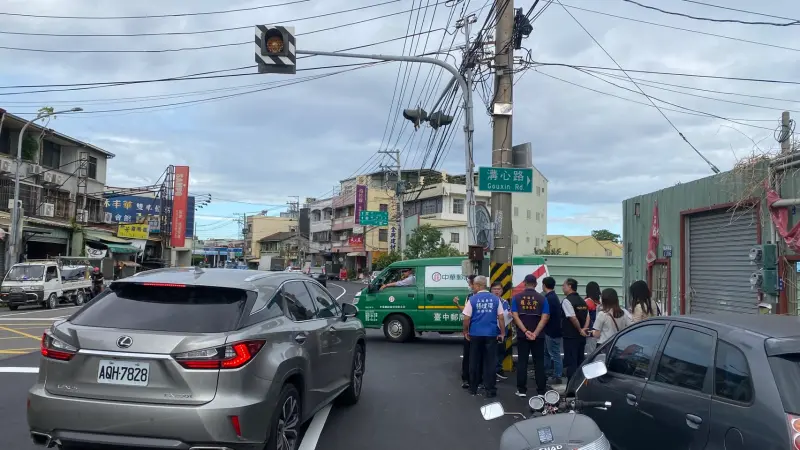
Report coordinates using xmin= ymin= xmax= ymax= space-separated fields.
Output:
xmin=256 ymin=25 xmax=297 ymax=75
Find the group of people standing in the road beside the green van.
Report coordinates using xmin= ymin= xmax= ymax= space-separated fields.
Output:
xmin=453 ymin=275 xmax=661 ymax=398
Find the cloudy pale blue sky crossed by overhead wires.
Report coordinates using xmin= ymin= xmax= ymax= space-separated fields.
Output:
xmin=0 ymin=0 xmax=800 ymax=238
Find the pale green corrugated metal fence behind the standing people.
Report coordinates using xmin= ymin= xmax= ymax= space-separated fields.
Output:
xmin=539 ymin=255 xmax=627 ymax=303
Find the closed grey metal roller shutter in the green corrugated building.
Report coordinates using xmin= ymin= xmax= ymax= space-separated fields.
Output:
xmin=686 ymin=211 xmax=758 ymax=314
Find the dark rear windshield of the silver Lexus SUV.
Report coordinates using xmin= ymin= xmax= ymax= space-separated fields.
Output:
xmin=70 ymin=282 xmax=257 ymax=333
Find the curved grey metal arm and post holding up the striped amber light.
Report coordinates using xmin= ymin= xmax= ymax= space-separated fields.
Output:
xmin=296 ymin=48 xmax=478 ymax=245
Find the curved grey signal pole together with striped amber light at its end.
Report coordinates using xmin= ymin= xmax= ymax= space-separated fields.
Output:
xmin=255 ymin=25 xmax=472 ymax=245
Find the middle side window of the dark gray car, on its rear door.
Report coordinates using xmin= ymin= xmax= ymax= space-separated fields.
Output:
xmin=654 ymin=327 xmax=714 ymax=392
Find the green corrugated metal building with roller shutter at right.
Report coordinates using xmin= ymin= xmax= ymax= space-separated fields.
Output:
xmin=622 ymin=158 xmax=800 ymax=315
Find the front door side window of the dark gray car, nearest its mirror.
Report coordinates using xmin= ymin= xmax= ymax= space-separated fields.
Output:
xmin=607 ymin=324 xmax=664 ymax=378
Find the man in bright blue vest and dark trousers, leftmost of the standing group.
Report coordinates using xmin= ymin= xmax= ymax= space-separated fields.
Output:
xmin=462 ymin=275 xmax=506 ymax=398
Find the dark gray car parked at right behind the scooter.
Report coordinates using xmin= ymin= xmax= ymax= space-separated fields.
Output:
xmin=568 ymin=313 xmax=800 ymax=450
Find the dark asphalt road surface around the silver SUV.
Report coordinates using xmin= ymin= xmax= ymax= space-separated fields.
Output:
xmin=0 ymin=282 xmax=526 ymax=450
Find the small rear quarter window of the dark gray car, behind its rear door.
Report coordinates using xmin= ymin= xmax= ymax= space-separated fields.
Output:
xmin=714 ymin=341 xmax=752 ymax=404
